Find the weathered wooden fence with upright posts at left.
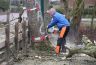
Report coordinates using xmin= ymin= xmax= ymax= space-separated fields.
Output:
xmin=0 ymin=21 xmax=31 ymax=65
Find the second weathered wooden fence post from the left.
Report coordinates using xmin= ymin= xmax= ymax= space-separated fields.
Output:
xmin=15 ymin=22 xmax=19 ymax=56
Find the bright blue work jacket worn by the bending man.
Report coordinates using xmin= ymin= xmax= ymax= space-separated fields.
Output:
xmin=48 ymin=12 xmax=70 ymax=30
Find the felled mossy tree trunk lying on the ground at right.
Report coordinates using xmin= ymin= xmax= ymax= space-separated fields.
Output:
xmin=66 ymin=36 xmax=96 ymax=58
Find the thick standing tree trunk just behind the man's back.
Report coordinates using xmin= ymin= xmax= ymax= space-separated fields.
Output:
xmin=71 ymin=0 xmax=84 ymax=42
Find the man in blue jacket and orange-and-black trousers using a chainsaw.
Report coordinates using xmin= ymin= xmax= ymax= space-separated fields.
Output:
xmin=47 ymin=7 xmax=70 ymax=55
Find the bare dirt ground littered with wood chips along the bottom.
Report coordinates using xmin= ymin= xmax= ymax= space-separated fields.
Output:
xmin=14 ymin=47 xmax=96 ymax=65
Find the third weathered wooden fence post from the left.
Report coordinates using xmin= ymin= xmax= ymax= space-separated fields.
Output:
xmin=22 ymin=21 xmax=27 ymax=55
